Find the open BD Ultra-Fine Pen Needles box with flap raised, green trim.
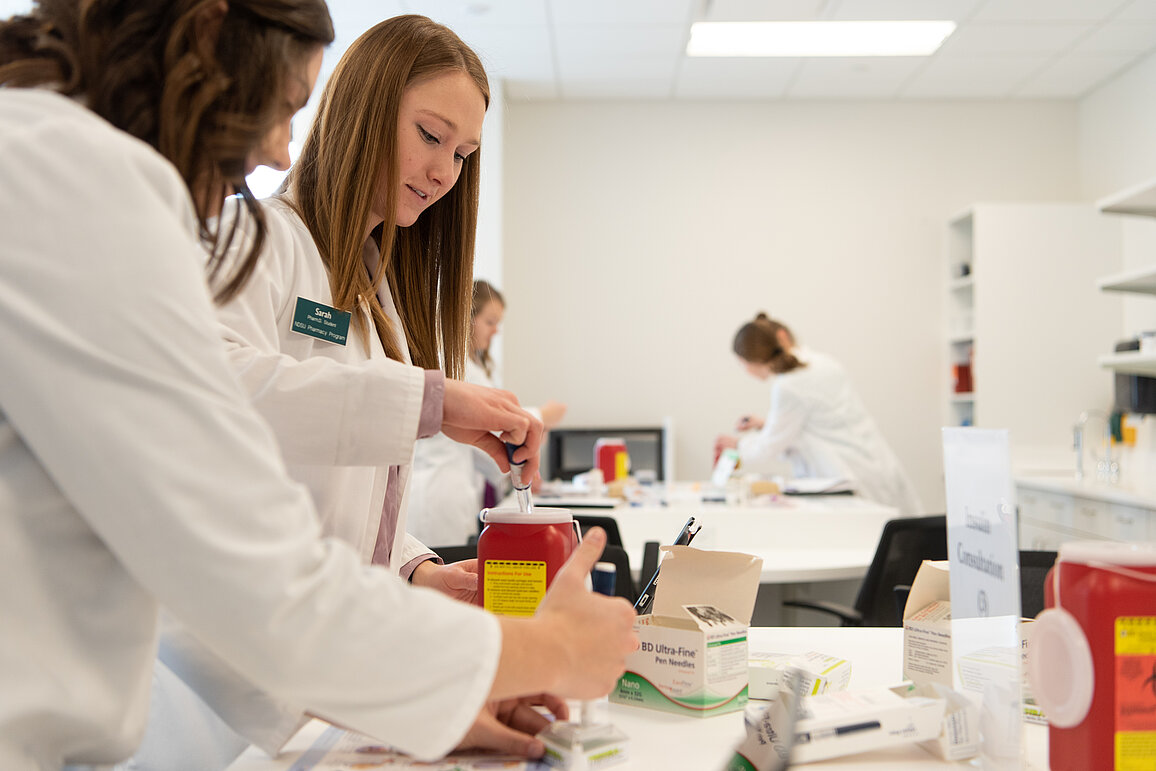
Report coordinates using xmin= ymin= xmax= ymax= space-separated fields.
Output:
xmin=610 ymin=546 xmax=763 ymax=717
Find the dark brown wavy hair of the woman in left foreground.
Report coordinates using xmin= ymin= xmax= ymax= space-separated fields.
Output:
xmin=0 ymin=0 xmax=333 ymax=302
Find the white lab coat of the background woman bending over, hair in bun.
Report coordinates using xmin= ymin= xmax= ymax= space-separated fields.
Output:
xmin=739 ymin=348 xmax=924 ymax=517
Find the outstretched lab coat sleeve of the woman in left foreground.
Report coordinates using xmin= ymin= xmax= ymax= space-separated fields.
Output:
xmin=0 ymin=104 xmax=501 ymax=758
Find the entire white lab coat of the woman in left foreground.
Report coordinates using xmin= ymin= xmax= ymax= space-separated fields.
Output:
xmin=0 ymin=88 xmax=501 ymax=771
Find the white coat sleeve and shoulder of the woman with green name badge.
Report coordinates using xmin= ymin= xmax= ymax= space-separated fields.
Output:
xmin=211 ymin=207 xmax=425 ymax=466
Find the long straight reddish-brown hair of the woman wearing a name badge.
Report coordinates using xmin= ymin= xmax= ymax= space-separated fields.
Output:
xmin=287 ymin=15 xmax=490 ymax=378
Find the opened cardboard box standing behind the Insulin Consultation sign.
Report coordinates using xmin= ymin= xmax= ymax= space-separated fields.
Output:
xmin=903 ymin=559 xmax=1047 ymax=724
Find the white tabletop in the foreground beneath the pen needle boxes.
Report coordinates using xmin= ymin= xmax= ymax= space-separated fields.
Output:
xmin=229 ymin=627 xmax=1047 ymax=771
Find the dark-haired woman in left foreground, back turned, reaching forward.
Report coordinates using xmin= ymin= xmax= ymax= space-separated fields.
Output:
xmin=0 ymin=0 xmax=637 ymax=771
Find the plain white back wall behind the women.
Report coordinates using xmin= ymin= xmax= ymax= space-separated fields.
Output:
xmin=503 ymin=102 xmax=1079 ymax=510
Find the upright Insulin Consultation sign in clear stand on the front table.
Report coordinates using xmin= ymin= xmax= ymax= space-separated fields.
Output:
xmin=943 ymin=428 xmax=1023 ymax=769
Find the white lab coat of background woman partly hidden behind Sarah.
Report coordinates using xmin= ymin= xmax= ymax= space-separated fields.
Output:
xmin=406 ymin=358 xmax=505 ymax=546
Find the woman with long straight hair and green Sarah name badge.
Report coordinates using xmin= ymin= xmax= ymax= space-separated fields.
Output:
xmin=138 ymin=16 xmax=601 ymax=756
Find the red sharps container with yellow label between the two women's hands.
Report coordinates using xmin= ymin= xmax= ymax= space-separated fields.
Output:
xmin=477 ymin=506 xmax=578 ymax=616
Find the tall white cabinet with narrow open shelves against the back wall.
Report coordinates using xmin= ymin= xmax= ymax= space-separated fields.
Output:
xmin=942 ymin=203 xmax=1121 ymax=451
